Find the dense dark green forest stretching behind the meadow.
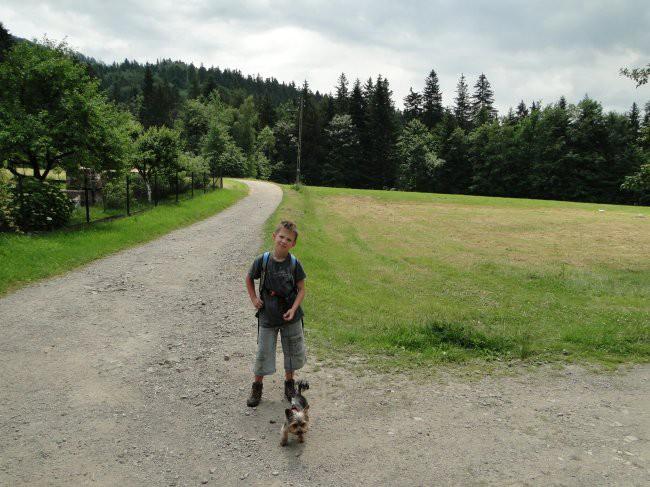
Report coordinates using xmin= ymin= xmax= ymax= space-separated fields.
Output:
xmin=0 ymin=22 xmax=650 ymax=204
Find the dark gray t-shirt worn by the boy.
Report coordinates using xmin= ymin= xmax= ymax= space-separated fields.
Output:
xmin=248 ymin=254 xmax=307 ymax=326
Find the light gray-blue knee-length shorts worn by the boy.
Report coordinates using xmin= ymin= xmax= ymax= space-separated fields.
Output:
xmin=253 ymin=320 xmax=307 ymax=375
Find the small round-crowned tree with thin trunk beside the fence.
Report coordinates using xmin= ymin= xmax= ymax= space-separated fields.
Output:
xmin=133 ymin=126 xmax=180 ymax=201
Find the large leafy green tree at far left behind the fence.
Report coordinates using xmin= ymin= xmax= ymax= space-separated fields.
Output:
xmin=0 ymin=40 xmax=135 ymax=180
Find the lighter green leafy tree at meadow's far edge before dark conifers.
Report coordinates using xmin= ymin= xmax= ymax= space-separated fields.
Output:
xmin=396 ymin=119 xmax=444 ymax=191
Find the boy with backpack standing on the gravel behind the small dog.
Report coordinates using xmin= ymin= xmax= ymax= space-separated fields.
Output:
xmin=246 ymin=220 xmax=307 ymax=407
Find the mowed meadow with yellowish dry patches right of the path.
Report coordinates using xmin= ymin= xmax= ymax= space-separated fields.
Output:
xmin=268 ymin=187 xmax=650 ymax=366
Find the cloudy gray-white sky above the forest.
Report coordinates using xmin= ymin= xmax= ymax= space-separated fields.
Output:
xmin=0 ymin=0 xmax=650 ymax=113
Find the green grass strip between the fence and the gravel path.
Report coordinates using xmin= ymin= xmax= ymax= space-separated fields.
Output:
xmin=0 ymin=181 xmax=248 ymax=294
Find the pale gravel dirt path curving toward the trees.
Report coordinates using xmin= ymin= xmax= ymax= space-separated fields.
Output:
xmin=0 ymin=182 xmax=650 ymax=486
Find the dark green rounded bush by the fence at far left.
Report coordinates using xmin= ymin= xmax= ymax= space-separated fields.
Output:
xmin=12 ymin=178 xmax=74 ymax=231
